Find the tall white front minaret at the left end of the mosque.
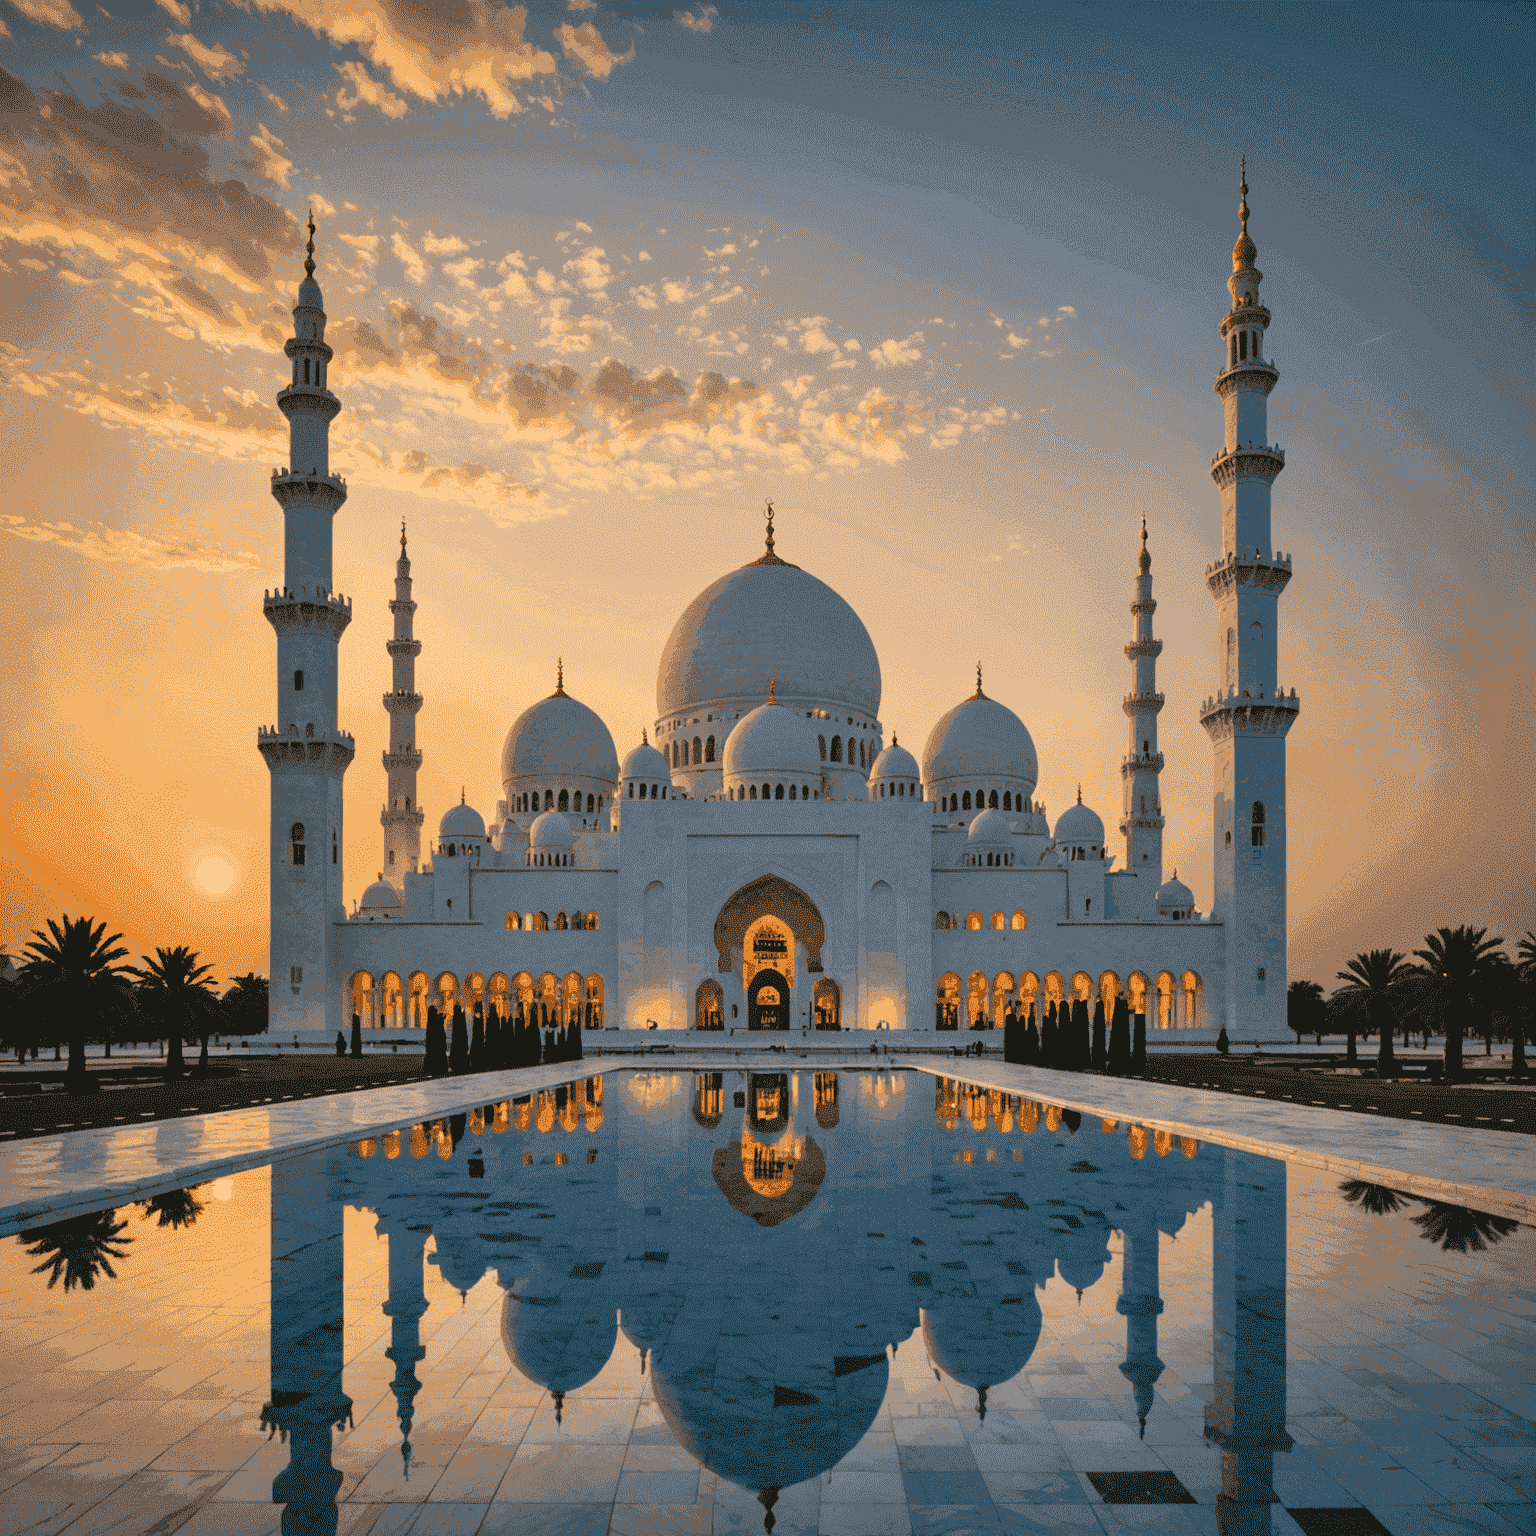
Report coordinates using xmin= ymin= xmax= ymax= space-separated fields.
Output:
xmin=257 ymin=217 xmax=355 ymax=1031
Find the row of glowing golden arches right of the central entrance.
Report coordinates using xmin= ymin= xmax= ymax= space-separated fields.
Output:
xmin=934 ymin=971 xmax=1206 ymax=1029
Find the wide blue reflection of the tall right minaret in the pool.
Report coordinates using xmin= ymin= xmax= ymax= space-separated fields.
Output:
xmin=1206 ymin=1149 xmax=1292 ymax=1536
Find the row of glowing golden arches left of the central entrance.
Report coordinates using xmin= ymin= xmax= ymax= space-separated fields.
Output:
xmin=346 ymin=971 xmax=605 ymax=1029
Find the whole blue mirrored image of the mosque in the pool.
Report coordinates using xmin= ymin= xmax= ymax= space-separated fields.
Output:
xmin=266 ymin=1072 xmax=1290 ymax=1533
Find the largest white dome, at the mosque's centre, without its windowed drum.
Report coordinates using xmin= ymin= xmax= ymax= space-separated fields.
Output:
xmin=656 ymin=536 xmax=880 ymax=719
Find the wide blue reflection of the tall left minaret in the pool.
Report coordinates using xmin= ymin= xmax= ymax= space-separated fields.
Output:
xmin=261 ymin=1150 xmax=352 ymax=1536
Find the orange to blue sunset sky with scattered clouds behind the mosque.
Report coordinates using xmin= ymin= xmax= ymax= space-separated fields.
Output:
xmin=0 ymin=0 xmax=1536 ymax=985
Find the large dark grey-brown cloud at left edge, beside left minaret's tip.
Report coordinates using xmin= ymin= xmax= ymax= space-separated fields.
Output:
xmin=0 ymin=68 xmax=301 ymax=292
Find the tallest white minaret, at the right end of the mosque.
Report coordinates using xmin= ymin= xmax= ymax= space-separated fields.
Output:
xmin=1200 ymin=160 xmax=1299 ymax=1040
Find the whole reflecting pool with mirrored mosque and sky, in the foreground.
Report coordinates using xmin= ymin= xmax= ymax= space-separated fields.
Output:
xmin=0 ymin=1071 xmax=1536 ymax=1536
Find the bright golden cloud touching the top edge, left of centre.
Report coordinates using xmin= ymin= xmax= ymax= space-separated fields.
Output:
xmin=237 ymin=0 xmax=558 ymax=118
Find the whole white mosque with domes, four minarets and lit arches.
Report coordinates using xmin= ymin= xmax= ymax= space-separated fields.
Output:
xmin=258 ymin=180 xmax=1299 ymax=1038
